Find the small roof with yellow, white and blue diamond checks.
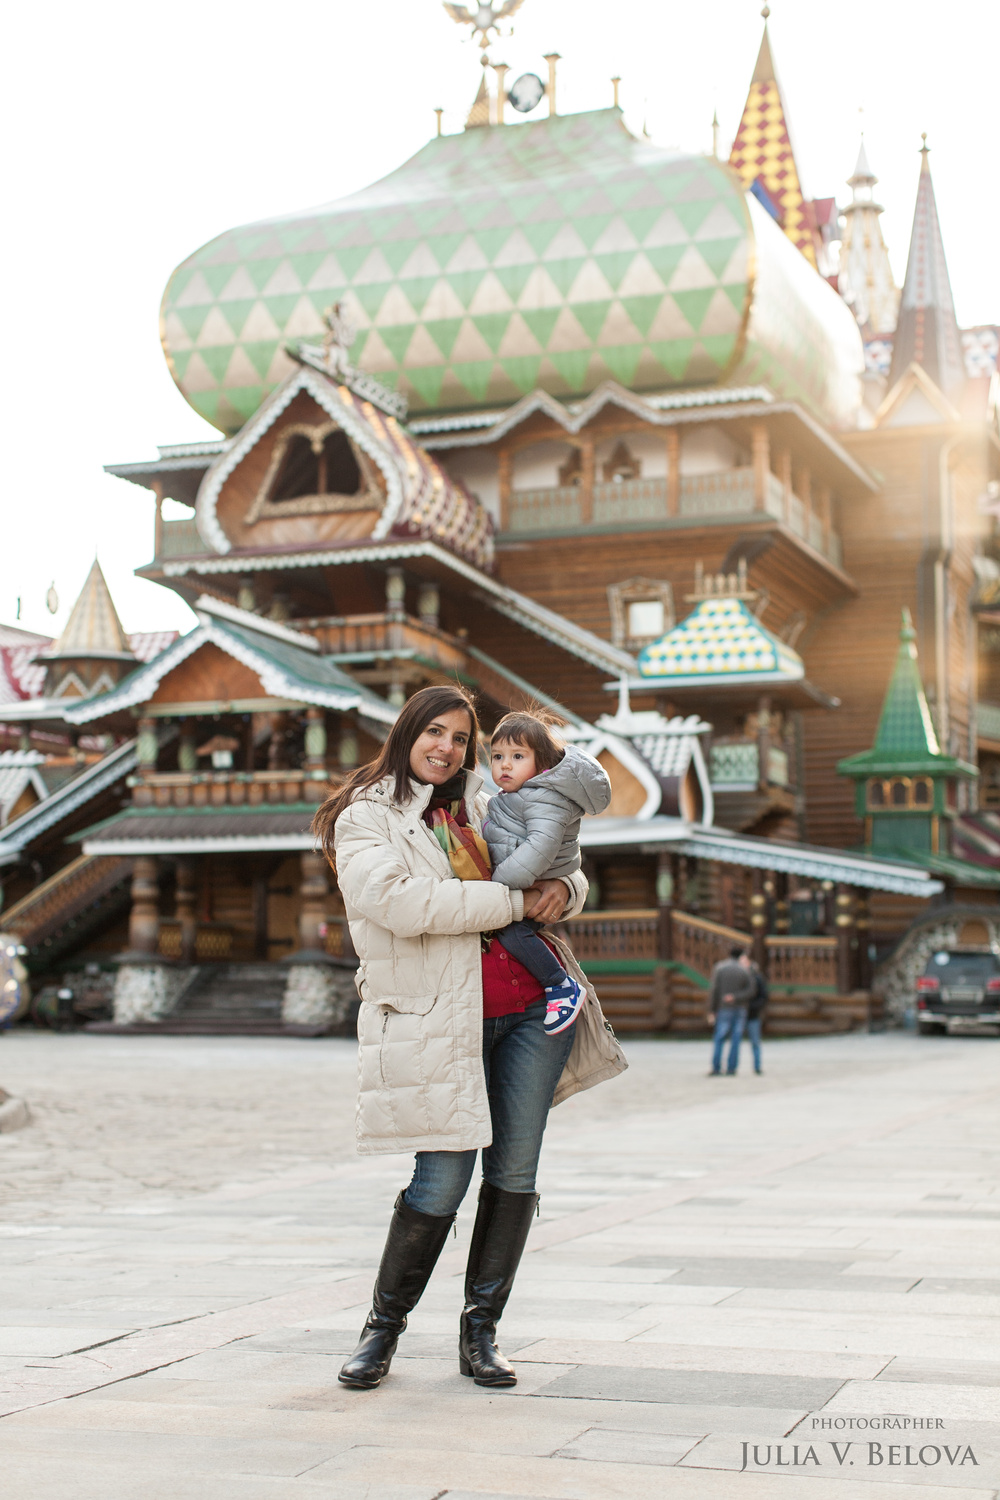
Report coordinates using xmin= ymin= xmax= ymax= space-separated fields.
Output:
xmin=639 ymin=596 xmax=805 ymax=687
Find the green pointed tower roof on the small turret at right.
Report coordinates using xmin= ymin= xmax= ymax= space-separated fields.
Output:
xmin=837 ymin=608 xmax=978 ymax=777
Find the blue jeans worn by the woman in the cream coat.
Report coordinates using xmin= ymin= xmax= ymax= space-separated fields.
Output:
xmin=405 ymin=1001 xmax=574 ymax=1218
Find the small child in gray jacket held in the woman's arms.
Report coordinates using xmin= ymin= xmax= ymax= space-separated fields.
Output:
xmin=483 ymin=713 xmax=612 ymax=1037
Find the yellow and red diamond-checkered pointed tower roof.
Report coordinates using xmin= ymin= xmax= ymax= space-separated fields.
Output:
xmin=729 ymin=16 xmax=816 ymax=269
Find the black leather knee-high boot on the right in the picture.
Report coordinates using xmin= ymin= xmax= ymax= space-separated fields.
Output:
xmin=459 ymin=1182 xmax=538 ymax=1386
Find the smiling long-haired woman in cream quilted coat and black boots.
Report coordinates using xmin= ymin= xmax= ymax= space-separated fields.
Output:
xmin=315 ymin=686 xmax=625 ymax=1389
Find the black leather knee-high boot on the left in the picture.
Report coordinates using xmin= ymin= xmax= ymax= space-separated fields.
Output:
xmin=337 ymin=1193 xmax=454 ymax=1391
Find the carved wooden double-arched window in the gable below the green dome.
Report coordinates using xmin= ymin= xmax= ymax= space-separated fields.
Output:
xmin=246 ymin=422 xmax=382 ymax=525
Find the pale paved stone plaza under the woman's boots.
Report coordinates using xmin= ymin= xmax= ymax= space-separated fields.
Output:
xmin=0 ymin=1032 xmax=1000 ymax=1500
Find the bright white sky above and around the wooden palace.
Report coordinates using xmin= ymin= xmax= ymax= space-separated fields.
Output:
xmin=0 ymin=0 xmax=1000 ymax=633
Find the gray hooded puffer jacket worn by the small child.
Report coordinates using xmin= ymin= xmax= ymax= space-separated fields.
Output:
xmin=483 ymin=746 xmax=612 ymax=891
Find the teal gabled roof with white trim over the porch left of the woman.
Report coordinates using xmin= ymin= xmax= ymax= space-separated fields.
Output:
xmin=64 ymin=597 xmax=397 ymax=725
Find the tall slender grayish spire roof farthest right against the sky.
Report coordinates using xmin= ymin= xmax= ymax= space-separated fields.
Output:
xmin=889 ymin=137 xmax=966 ymax=396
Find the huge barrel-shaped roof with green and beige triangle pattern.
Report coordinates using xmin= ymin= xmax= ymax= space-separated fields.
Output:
xmin=160 ymin=110 xmax=862 ymax=432
